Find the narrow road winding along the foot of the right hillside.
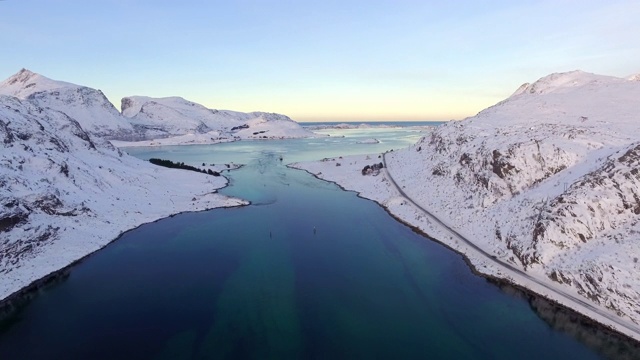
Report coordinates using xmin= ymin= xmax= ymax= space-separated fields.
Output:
xmin=382 ymin=153 xmax=640 ymax=340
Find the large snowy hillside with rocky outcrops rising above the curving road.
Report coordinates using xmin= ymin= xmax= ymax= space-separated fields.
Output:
xmin=300 ymin=71 xmax=640 ymax=334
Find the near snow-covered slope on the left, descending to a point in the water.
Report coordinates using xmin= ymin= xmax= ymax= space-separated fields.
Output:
xmin=0 ymin=93 xmax=243 ymax=300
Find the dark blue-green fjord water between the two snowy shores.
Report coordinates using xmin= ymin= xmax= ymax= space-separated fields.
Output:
xmin=0 ymin=131 xmax=624 ymax=359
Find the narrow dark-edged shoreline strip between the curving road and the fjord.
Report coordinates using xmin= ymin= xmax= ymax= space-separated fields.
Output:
xmin=287 ymin=160 xmax=640 ymax=350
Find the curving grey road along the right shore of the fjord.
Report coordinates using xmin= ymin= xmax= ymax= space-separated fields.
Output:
xmin=382 ymin=153 xmax=640 ymax=341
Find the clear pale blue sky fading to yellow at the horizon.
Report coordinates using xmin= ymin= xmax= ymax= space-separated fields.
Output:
xmin=0 ymin=0 xmax=640 ymax=121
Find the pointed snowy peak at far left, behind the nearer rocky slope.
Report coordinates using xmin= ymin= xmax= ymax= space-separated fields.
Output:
xmin=0 ymin=69 xmax=140 ymax=140
